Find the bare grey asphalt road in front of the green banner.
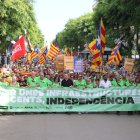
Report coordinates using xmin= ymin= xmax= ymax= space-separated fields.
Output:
xmin=0 ymin=114 xmax=140 ymax=140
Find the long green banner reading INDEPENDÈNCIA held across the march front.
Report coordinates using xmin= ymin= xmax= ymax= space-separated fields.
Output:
xmin=0 ymin=87 xmax=140 ymax=112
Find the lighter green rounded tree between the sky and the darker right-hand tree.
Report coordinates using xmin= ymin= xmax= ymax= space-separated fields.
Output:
xmin=58 ymin=13 xmax=95 ymax=50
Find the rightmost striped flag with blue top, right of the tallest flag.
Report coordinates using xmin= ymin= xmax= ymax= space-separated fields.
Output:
xmin=107 ymin=41 xmax=122 ymax=65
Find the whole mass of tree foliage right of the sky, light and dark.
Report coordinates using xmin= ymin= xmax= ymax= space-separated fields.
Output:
xmin=58 ymin=0 xmax=140 ymax=55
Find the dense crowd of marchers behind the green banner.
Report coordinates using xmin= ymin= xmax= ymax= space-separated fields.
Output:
xmin=0 ymin=57 xmax=140 ymax=89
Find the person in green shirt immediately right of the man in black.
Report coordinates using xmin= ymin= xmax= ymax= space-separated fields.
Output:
xmin=74 ymin=74 xmax=86 ymax=88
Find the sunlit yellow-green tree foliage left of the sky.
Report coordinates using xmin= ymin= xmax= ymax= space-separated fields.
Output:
xmin=0 ymin=0 xmax=44 ymax=52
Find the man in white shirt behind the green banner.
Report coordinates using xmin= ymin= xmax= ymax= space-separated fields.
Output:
xmin=99 ymin=74 xmax=111 ymax=88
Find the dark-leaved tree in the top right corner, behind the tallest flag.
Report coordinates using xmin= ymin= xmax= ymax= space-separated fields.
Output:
xmin=93 ymin=0 xmax=140 ymax=56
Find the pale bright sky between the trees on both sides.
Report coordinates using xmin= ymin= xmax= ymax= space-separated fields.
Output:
xmin=34 ymin=0 xmax=95 ymax=44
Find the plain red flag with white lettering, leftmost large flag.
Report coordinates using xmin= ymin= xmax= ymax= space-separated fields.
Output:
xmin=12 ymin=36 xmax=26 ymax=61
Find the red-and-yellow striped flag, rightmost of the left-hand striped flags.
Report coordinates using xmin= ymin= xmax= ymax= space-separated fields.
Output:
xmin=47 ymin=43 xmax=60 ymax=59
